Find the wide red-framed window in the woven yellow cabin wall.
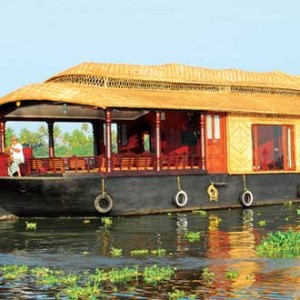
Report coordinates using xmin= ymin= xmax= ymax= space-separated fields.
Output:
xmin=252 ymin=125 xmax=295 ymax=171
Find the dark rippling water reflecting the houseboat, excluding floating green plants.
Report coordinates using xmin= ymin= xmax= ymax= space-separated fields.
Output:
xmin=0 ymin=204 xmax=300 ymax=299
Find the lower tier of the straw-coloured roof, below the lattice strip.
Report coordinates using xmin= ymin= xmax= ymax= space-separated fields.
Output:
xmin=0 ymin=82 xmax=300 ymax=115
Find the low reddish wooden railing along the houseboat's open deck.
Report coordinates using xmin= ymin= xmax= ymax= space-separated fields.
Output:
xmin=21 ymin=153 xmax=201 ymax=175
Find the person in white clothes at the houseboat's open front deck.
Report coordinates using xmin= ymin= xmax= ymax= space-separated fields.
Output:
xmin=7 ymin=136 xmax=24 ymax=177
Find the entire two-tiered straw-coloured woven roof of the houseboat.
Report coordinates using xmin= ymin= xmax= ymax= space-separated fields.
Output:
xmin=0 ymin=63 xmax=300 ymax=115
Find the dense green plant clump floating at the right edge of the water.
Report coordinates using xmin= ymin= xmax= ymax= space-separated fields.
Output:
xmin=256 ymin=230 xmax=300 ymax=258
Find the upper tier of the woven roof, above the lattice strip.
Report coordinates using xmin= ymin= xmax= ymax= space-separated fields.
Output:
xmin=47 ymin=62 xmax=300 ymax=90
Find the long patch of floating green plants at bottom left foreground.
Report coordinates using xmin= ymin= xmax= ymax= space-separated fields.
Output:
xmin=0 ymin=265 xmax=177 ymax=299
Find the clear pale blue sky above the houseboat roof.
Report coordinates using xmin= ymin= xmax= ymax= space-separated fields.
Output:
xmin=0 ymin=0 xmax=300 ymax=131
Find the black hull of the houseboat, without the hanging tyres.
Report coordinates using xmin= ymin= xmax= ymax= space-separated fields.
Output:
xmin=0 ymin=173 xmax=299 ymax=219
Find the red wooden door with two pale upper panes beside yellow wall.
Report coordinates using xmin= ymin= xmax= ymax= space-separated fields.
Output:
xmin=206 ymin=113 xmax=226 ymax=173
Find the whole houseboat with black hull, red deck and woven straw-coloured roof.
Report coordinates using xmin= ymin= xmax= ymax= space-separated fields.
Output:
xmin=0 ymin=63 xmax=300 ymax=219
